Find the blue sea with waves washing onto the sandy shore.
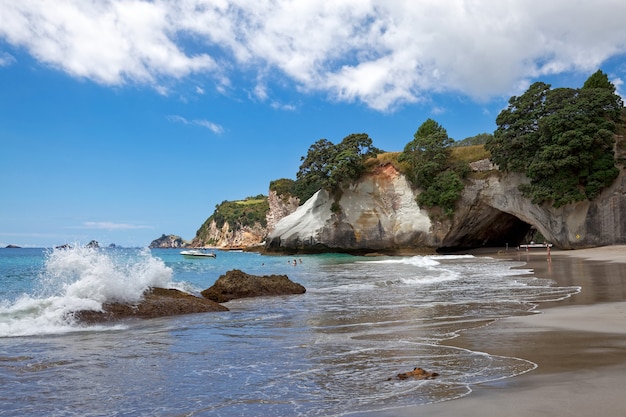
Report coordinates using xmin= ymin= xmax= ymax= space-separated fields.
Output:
xmin=0 ymin=247 xmax=580 ymax=417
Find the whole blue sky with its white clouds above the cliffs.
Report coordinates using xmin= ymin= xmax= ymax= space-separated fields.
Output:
xmin=0 ymin=0 xmax=626 ymax=247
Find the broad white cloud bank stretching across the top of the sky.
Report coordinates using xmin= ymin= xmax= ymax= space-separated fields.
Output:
xmin=0 ymin=0 xmax=626 ymax=111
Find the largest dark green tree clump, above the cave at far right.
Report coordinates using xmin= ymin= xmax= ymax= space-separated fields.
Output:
xmin=485 ymin=71 xmax=623 ymax=207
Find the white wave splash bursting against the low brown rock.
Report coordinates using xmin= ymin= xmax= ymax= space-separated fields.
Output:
xmin=0 ymin=247 xmax=172 ymax=337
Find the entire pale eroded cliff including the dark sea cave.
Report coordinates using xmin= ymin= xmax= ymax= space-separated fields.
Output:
xmin=266 ymin=165 xmax=626 ymax=252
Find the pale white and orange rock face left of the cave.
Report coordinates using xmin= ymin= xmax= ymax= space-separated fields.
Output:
xmin=266 ymin=165 xmax=439 ymax=252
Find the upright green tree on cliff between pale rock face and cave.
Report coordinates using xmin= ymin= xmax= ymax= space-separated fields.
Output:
xmin=398 ymin=119 xmax=467 ymax=216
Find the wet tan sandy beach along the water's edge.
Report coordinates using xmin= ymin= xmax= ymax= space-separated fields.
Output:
xmin=366 ymin=246 xmax=626 ymax=417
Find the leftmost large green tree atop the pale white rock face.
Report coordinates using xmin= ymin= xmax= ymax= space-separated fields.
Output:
xmin=294 ymin=133 xmax=381 ymax=202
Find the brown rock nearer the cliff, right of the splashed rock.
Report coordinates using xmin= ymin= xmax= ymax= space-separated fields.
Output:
xmin=202 ymin=269 xmax=306 ymax=303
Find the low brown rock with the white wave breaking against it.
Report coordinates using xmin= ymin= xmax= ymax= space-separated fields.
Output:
xmin=74 ymin=288 xmax=228 ymax=323
